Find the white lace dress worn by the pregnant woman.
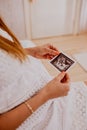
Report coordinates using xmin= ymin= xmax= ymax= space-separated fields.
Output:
xmin=0 ymin=41 xmax=87 ymax=130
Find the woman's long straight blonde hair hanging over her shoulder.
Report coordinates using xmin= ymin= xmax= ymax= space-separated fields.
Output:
xmin=0 ymin=17 xmax=27 ymax=61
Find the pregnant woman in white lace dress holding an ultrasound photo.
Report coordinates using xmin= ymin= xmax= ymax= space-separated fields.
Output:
xmin=0 ymin=18 xmax=87 ymax=130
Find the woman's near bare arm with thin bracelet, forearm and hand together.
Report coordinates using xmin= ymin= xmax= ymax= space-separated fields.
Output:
xmin=0 ymin=72 xmax=70 ymax=130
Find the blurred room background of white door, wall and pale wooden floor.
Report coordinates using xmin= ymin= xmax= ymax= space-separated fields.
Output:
xmin=0 ymin=0 xmax=87 ymax=81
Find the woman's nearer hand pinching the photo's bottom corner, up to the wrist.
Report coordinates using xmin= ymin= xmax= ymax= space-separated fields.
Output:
xmin=42 ymin=72 xmax=70 ymax=100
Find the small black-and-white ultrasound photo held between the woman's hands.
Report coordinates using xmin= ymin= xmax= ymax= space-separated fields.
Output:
xmin=50 ymin=53 xmax=74 ymax=72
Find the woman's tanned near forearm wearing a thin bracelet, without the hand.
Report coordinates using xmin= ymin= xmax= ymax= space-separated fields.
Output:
xmin=0 ymin=92 xmax=48 ymax=130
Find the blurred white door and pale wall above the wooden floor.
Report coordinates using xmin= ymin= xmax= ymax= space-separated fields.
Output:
xmin=0 ymin=0 xmax=87 ymax=39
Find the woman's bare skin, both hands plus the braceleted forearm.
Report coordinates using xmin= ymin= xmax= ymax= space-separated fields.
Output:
xmin=0 ymin=44 xmax=87 ymax=130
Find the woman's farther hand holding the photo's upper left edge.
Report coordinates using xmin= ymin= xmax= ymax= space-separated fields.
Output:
xmin=26 ymin=44 xmax=59 ymax=59
